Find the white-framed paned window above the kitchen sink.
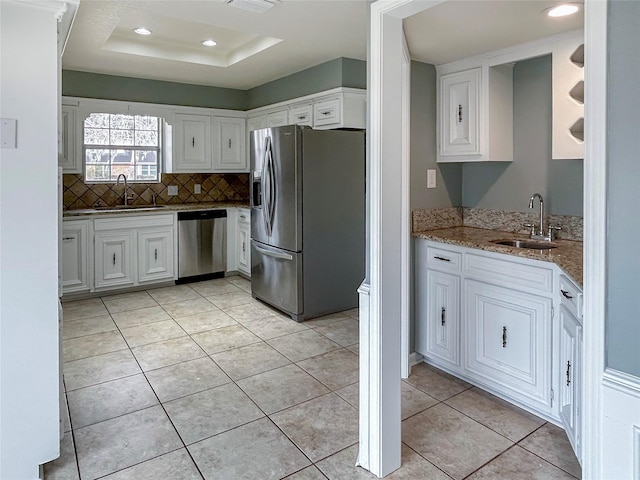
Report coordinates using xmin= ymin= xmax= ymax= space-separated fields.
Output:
xmin=83 ymin=113 xmax=162 ymax=183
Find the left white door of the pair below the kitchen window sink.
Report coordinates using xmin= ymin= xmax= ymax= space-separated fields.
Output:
xmin=95 ymin=232 xmax=134 ymax=288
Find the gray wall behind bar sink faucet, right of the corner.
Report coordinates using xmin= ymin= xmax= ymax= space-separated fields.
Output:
xmin=462 ymin=55 xmax=583 ymax=216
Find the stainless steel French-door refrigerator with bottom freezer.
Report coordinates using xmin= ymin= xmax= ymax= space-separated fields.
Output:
xmin=250 ymin=125 xmax=365 ymax=321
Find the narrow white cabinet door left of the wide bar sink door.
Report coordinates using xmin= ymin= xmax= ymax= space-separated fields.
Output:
xmin=416 ymin=270 xmax=460 ymax=366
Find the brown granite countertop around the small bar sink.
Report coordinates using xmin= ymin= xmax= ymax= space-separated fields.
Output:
xmin=412 ymin=227 xmax=582 ymax=287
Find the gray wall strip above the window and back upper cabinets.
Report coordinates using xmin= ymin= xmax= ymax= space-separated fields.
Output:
xmin=62 ymin=70 xmax=247 ymax=110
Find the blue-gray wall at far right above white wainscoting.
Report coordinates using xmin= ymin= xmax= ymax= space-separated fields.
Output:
xmin=606 ymin=2 xmax=640 ymax=377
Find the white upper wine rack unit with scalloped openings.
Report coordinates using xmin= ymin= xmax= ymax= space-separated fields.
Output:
xmin=551 ymin=34 xmax=584 ymax=159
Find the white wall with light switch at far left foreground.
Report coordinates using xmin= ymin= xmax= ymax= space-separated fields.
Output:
xmin=0 ymin=0 xmax=59 ymax=480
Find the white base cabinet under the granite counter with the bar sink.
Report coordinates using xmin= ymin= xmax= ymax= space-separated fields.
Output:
xmin=415 ymin=239 xmax=582 ymax=450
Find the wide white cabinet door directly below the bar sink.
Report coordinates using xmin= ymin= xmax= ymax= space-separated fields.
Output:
xmin=464 ymin=280 xmax=552 ymax=410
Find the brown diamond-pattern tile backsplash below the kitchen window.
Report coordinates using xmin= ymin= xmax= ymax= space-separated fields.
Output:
xmin=62 ymin=173 xmax=249 ymax=210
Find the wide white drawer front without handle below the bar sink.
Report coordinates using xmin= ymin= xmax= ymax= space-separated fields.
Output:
xmin=464 ymin=254 xmax=553 ymax=293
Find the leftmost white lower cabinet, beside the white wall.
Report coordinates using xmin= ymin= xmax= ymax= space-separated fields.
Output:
xmin=61 ymin=220 xmax=93 ymax=295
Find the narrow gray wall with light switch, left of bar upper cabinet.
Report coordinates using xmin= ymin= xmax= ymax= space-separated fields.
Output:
xmin=410 ymin=61 xmax=462 ymax=210
